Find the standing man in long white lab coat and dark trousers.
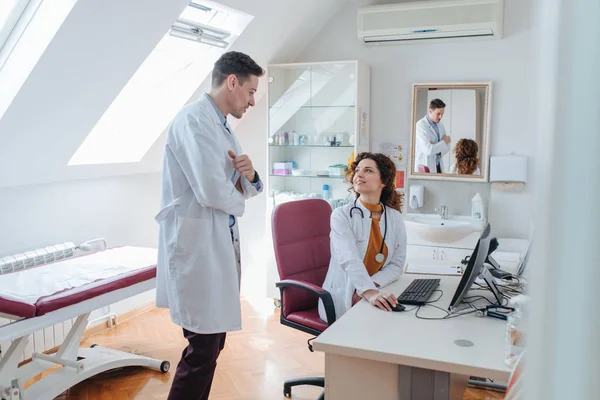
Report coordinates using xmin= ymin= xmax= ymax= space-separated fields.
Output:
xmin=156 ymin=52 xmax=264 ymax=400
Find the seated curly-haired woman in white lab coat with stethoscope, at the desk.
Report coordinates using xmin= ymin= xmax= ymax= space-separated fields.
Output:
xmin=319 ymin=153 xmax=406 ymax=321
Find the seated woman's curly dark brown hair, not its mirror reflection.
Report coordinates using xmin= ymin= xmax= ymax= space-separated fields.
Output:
xmin=346 ymin=152 xmax=403 ymax=212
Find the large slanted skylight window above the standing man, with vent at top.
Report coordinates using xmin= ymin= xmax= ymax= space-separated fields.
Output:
xmin=69 ymin=1 xmax=253 ymax=165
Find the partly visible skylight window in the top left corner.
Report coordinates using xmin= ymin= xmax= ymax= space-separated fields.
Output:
xmin=0 ymin=0 xmax=77 ymax=118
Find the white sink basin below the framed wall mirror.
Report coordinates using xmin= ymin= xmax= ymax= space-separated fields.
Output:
xmin=405 ymin=214 xmax=483 ymax=243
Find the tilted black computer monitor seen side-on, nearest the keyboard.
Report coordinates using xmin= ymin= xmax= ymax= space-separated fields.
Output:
xmin=448 ymin=224 xmax=502 ymax=312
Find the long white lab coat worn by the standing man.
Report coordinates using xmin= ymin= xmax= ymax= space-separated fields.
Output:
xmin=156 ymin=95 xmax=262 ymax=334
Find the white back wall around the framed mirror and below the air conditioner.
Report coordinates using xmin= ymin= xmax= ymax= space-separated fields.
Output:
xmin=295 ymin=0 xmax=534 ymax=237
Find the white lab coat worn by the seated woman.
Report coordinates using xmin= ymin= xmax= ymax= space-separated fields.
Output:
xmin=319 ymin=200 xmax=406 ymax=321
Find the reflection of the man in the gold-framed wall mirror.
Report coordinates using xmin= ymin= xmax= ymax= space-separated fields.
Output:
xmin=414 ymin=99 xmax=450 ymax=174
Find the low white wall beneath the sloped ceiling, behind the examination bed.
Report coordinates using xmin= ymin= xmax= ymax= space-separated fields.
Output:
xmin=0 ymin=173 xmax=160 ymax=255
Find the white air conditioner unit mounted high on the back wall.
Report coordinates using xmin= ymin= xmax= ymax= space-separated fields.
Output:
xmin=358 ymin=0 xmax=504 ymax=44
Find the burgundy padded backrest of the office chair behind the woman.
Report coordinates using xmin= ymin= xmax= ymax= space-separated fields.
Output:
xmin=272 ymin=199 xmax=331 ymax=315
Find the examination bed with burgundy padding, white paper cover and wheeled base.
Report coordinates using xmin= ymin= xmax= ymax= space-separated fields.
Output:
xmin=0 ymin=247 xmax=169 ymax=400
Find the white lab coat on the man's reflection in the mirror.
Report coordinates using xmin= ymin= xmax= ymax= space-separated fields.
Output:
xmin=414 ymin=116 xmax=450 ymax=174
